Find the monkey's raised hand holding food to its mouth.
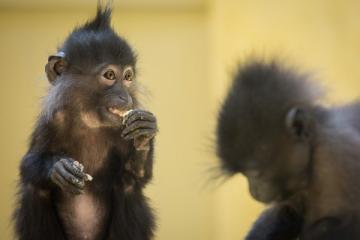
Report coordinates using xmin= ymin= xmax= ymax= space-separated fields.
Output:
xmin=121 ymin=109 xmax=158 ymax=150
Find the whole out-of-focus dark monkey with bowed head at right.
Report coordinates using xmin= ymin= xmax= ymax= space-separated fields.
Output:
xmin=217 ymin=60 xmax=360 ymax=240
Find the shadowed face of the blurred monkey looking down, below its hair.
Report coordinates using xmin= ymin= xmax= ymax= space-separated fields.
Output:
xmin=225 ymin=135 xmax=310 ymax=203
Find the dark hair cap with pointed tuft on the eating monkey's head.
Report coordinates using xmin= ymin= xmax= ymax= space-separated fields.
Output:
xmin=58 ymin=3 xmax=136 ymax=73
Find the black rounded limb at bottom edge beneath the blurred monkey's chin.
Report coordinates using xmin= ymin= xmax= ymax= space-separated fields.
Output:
xmin=245 ymin=205 xmax=303 ymax=240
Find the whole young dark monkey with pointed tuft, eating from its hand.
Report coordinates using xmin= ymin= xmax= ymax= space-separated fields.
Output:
xmin=14 ymin=6 xmax=157 ymax=240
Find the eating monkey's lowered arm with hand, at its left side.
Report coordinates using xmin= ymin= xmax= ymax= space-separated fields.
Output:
xmin=20 ymin=119 xmax=87 ymax=194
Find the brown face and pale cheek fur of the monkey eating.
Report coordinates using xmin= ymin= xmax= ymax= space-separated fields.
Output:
xmin=48 ymin=59 xmax=137 ymax=128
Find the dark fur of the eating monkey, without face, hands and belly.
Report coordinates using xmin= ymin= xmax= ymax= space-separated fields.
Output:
xmin=14 ymin=7 xmax=155 ymax=240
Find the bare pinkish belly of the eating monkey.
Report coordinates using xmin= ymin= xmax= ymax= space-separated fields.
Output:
xmin=57 ymin=192 xmax=109 ymax=240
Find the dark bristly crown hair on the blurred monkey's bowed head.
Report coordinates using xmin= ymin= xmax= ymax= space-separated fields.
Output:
xmin=216 ymin=58 xmax=322 ymax=173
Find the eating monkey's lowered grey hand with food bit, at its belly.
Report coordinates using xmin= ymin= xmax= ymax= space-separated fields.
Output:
xmin=49 ymin=158 xmax=92 ymax=194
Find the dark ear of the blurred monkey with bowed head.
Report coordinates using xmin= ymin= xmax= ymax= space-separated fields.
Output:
xmin=285 ymin=107 xmax=312 ymax=140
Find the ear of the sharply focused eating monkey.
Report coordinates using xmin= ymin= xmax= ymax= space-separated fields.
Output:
xmin=45 ymin=52 xmax=67 ymax=84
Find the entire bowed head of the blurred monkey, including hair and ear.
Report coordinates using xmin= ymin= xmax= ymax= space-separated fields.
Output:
xmin=217 ymin=61 xmax=318 ymax=203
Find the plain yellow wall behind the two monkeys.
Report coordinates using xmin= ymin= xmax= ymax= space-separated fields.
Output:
xmin=0 ymin=0 xmax=360 ymax=240
